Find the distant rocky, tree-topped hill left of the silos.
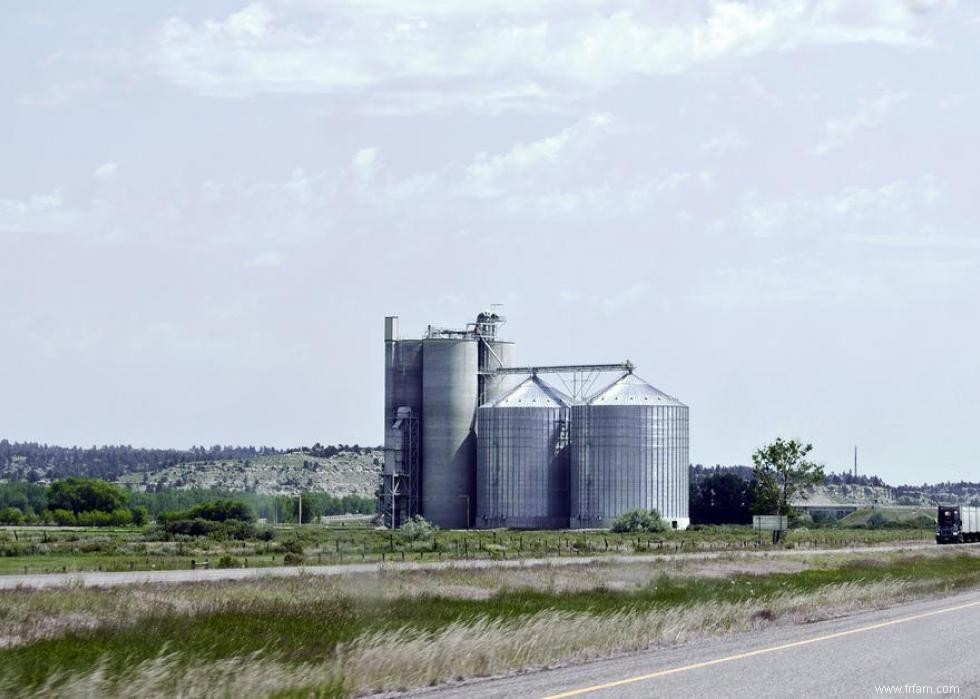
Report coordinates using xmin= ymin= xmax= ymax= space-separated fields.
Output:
xmin=0 ymin=440 xmax=383 ymax=497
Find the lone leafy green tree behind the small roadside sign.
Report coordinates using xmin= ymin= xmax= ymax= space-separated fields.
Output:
xmin=752 ymin=437 xmax=824 ymax=515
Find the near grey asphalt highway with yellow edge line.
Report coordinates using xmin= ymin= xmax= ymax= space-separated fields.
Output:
xmin=416 ymin=591 xmax=980 ymax=699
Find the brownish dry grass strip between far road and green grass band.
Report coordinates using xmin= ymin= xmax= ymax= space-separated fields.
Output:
xmin=0 ymin=548 xmax=963 ymax=648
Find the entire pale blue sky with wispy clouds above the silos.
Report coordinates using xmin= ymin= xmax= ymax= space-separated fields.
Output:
xmin=0 ymin=0 xmax=980 ymax=483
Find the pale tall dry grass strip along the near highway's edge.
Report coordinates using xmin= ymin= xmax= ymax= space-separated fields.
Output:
xmin=0 ymin=582 xmax=925 ymax=697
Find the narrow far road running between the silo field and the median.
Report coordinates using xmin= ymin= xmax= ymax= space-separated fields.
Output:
xmin=0 ymin=543 xmax=936 ymax=590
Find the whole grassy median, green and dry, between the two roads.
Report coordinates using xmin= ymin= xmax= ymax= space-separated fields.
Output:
xmin=0 ymin=548 xmax=980 ymax=696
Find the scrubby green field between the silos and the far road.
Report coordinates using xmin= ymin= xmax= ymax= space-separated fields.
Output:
xmin=0 ymin=524 xmax=934 ymax=574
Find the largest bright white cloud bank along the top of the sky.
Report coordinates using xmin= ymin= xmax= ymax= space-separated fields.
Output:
xmin=149 ymin=0 xmax=944 ymax=112
